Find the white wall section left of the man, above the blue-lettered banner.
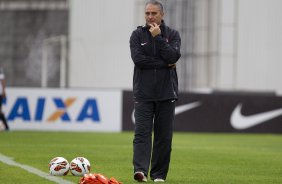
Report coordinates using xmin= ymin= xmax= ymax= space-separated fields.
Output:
xmin=69 ymin=0 xmax=134 ymax=89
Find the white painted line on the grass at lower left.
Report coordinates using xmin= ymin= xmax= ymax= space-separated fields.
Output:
xmin=0 ymin=153 xmax=73 ymax=184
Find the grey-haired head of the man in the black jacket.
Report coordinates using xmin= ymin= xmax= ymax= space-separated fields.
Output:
xmin=145 ymin=4 xmax=164 ymax=25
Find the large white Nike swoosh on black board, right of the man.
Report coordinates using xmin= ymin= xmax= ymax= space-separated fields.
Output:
xmin=230 ymin=104 xmax=282 ymax=130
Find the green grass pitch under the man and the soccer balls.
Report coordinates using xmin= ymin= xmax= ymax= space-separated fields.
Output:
xmin=0 ymin=131 xmax=282 ymax=184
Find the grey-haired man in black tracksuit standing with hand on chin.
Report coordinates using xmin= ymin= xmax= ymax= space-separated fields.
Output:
xmin=130 ymin=0 xmax=181 ymax=182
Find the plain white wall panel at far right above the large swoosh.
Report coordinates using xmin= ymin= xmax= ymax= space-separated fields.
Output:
xmin=236 ymin=0 xmax=282 ymax=94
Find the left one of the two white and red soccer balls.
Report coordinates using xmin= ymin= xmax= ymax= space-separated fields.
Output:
xmin=49 ymin=157 xmax=70 ymax=176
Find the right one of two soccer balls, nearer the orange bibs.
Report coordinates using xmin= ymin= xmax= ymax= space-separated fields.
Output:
xmin=70 ymin=157 xmax=90 ymax=176
